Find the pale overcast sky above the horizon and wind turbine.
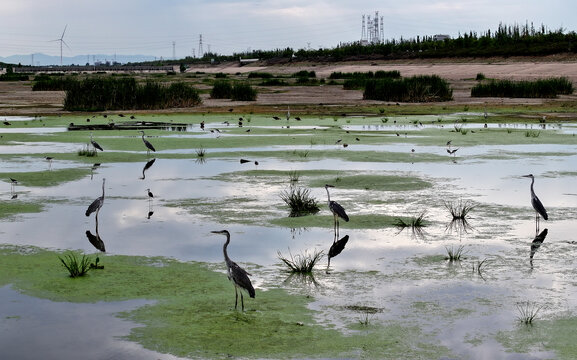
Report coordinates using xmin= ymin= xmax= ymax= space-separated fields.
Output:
xmin=0 ymin=0 xmax=577 ymax=58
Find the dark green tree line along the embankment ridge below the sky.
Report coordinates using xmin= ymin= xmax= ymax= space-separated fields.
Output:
xmin=145 ymin=23 xmax=577 ymax=64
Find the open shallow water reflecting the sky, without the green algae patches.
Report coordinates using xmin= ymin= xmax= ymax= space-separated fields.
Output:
xmin=0 ymin=116 xmax=577 ymax=359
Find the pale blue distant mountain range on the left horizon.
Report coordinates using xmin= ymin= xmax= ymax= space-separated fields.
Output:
xmin=0 ymin=53 xmax=159 ymax=66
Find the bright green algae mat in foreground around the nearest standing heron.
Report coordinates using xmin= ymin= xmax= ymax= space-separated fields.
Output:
xmin=0 ymin=245 xmax=449 ymax=359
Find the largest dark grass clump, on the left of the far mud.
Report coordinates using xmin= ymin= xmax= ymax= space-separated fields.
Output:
xmin=64 ymin=77 xmax=201 ymax=111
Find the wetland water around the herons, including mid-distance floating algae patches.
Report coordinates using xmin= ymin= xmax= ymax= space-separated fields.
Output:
xmin=0 ymin=115 xmax=577 ymax=359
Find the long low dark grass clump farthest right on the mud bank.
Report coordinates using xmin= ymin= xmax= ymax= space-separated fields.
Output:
xmin=471 ymin=77 xmax=574 ymax=98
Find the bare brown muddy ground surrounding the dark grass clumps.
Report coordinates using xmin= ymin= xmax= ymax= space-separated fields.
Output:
xmin=0 ymin=57 xmax=577 ymax=116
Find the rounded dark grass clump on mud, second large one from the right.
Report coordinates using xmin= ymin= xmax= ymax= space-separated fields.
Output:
xmin=363 ymin=75 xmax=453 ymax=102
